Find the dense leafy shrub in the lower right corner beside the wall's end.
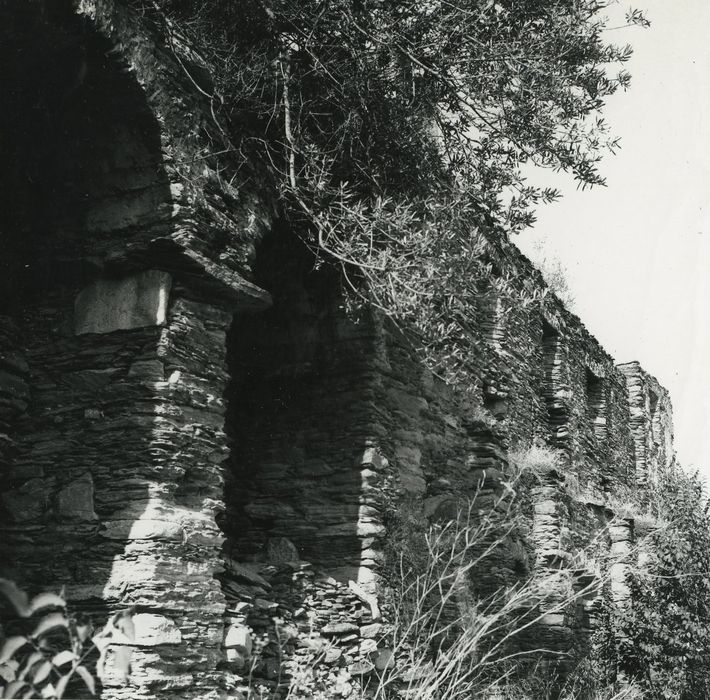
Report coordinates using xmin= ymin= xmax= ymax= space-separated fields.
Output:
xmin=617 ymin=468 xmax=710 ymax=700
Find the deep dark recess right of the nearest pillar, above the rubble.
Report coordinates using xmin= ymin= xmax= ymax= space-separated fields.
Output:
xmin=225 ymin=223 xmax=381 ymax=584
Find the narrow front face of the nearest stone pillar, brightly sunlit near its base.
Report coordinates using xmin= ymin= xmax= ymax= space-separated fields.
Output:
xmin=96 ymin=288 xmax=231 ymax=698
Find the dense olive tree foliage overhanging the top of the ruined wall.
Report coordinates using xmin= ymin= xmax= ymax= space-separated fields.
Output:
xmin=149 ymin=0 xmax=648 ymax=380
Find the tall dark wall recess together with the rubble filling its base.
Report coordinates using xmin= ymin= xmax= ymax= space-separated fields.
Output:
xmin=222 ymin=222 xmax=392 ymax=697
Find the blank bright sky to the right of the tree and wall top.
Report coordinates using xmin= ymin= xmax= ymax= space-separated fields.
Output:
xmin=516 ymin=0 xmax=710 ymax=481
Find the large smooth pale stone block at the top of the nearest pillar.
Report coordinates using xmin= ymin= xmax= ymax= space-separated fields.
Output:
xmin=74 ymin=270 xmax=172 ymax=335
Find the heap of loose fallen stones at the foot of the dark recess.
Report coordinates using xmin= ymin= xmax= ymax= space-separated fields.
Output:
xmin=224 ymin=561 xmax=392 ymax=697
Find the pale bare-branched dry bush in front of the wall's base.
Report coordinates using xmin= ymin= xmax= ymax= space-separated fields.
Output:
xmin=371 ymin=474 xmax=599 ymax=700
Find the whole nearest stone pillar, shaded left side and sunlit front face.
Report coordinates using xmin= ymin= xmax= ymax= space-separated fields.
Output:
xmin=0 ymin=271 xmax=232 ymax=699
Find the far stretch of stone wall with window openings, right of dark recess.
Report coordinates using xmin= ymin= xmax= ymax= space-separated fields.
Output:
xmin=362 ymin=237 xmax=673 ymax=672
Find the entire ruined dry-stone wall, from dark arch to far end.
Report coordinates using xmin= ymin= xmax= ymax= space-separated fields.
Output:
xmin=0 ymin=0 xmax=673 ymax=698
